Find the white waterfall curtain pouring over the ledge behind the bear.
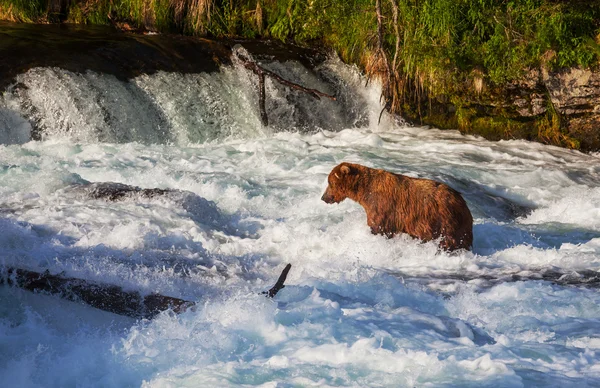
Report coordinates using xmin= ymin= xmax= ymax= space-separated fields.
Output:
xmin=0 ymin=53 xmax=380 ymax=145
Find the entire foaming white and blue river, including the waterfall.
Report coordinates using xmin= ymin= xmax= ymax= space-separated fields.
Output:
xmin=0 ymin=56 xmax=600 ymax=387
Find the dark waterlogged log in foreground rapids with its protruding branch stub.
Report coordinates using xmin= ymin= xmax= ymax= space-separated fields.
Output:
xmin=0 ymin=264 xmax=292 ymax=319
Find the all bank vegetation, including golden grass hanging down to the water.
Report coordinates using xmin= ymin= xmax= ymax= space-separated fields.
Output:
xmin=0 ymin=0 xmax=600 ymax=149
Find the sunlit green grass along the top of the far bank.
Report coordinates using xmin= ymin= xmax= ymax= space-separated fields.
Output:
xmin=0 ymin=0 xmax=600 ymax=82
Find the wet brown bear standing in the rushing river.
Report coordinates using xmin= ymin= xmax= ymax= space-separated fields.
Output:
xmin=321 ymin=163 xmax=473 ymax=251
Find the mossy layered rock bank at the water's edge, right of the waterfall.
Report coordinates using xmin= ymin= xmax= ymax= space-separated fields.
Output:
xmin=420 ymin=67 xmax=600 ymax=152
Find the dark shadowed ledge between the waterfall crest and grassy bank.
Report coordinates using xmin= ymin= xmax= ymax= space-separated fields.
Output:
xmin=0 ymin=22 xmax=325 ymax=90
